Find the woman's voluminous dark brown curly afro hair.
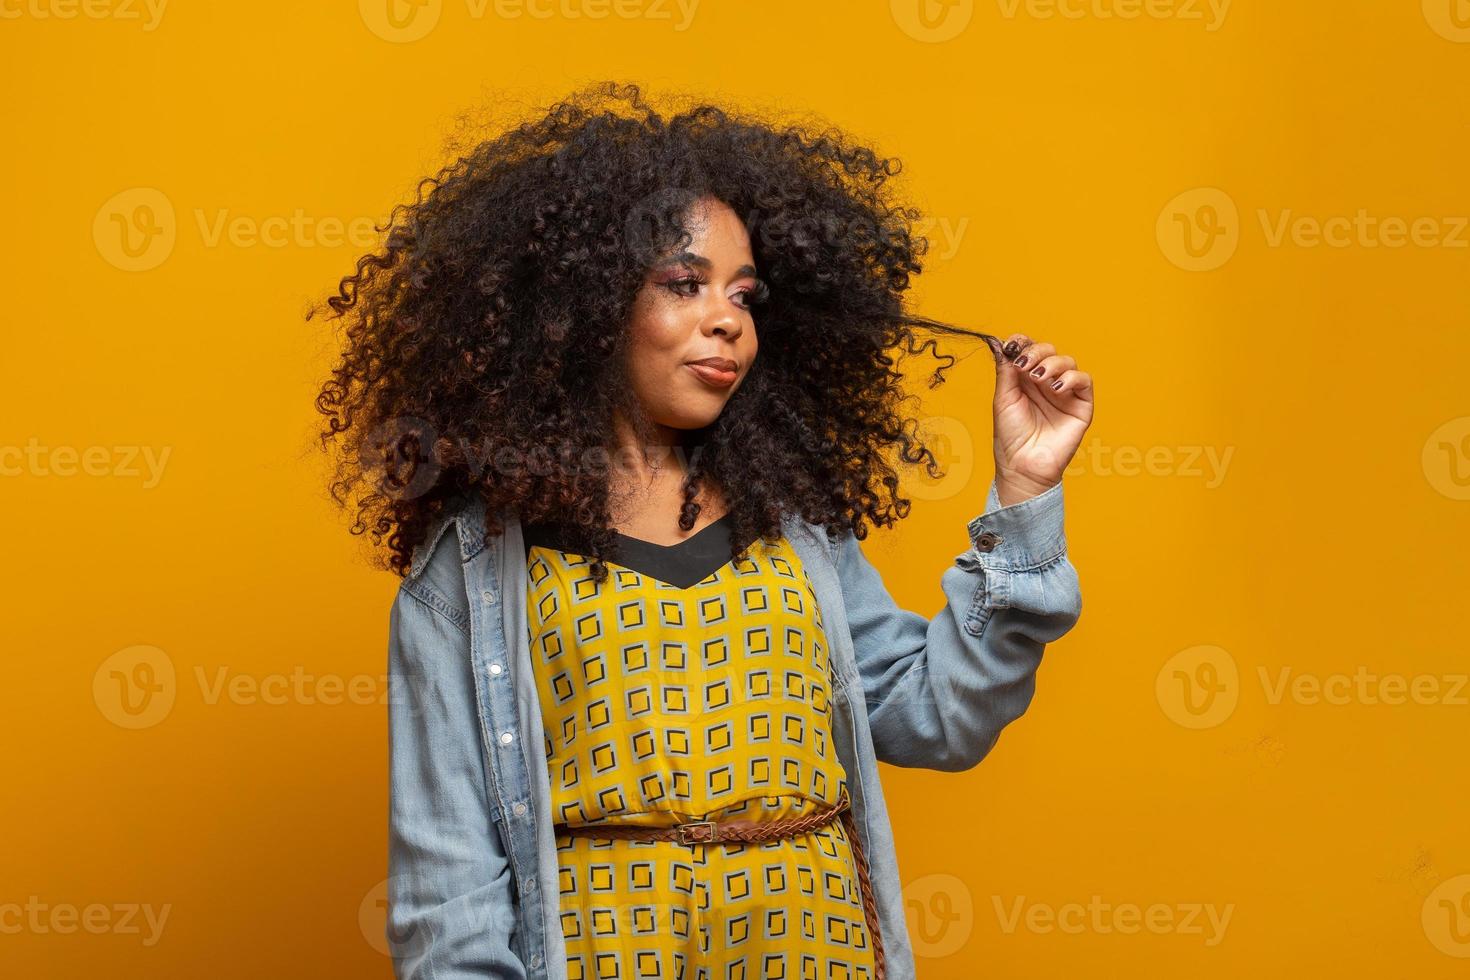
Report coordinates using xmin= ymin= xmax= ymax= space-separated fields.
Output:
xmin=307 ymin=82 xmax=1001 ymax=582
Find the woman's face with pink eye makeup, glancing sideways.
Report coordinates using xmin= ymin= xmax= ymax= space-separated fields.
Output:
xmin=628 ymin=197 xmax=760 ymax=429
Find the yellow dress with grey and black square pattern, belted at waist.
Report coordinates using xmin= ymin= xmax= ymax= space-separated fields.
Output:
xmin=525 ymin=516 xmax=873 ymax=980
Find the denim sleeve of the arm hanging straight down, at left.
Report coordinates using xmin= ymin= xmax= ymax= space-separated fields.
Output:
xmin=388 ymin=535 xmax=526 ymax=980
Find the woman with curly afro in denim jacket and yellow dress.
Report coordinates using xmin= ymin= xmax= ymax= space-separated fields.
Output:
xmin=318 ymin=84 xmax=1092 ymax=980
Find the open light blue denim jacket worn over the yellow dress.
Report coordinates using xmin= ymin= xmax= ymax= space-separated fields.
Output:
xmin=387 ymin=482 xmax=1082 ymax=980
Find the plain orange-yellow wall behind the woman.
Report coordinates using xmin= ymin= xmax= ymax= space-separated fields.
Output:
xmin=0 ymin=0 xmax=1470 ymax=980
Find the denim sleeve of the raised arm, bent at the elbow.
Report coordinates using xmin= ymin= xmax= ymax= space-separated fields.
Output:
xmin=838 ymin=482 xmax=1082 ymax=771
